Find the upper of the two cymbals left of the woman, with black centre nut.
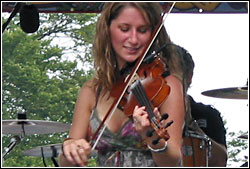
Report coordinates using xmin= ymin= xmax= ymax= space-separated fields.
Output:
xmin=2 ymin=119 xmax=70 ymax=135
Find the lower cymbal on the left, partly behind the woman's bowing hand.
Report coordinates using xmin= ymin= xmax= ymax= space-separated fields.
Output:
xmin=22 ymin=144 xmax=62 ymax=157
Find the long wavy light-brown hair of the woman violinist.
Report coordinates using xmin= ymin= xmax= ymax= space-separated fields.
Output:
xmin=93 ymin=2 xmax=182 ymax=93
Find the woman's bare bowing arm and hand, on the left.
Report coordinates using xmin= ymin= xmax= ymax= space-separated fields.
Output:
xmin=59 ymin=82 xmax=95 ymax=167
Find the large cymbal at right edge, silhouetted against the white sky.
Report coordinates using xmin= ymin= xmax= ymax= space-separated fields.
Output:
xmin=201 ymin=87 xmax=248 ymax=99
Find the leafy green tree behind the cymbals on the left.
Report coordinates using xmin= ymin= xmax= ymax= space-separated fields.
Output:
xmin=2 ymin=14 xmax=96 ymax=167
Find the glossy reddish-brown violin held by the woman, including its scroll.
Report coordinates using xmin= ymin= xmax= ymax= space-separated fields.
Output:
xmin=110 ymin=53 xmax=173 ymax=144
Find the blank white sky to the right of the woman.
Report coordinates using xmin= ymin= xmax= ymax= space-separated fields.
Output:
xmin=165 ymin=14 xmax=249 ymax=165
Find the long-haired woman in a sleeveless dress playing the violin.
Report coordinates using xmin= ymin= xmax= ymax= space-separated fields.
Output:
xmin=59 ymin=2 xmax=185 ymax=167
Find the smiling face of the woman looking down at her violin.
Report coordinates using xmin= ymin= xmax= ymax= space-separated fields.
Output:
xmin=110 ymin=6 xmax=152 ymax=69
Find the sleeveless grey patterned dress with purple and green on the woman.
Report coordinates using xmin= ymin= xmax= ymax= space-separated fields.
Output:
xmin=88 ymin=109 xmax=156 ymax=167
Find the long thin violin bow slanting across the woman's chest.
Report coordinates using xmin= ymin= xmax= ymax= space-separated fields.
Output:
xmin=91 ymin=2 xmax=176 ymax=151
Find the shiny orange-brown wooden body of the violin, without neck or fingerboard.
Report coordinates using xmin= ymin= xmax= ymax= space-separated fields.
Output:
xmin=111 ymin=57 xmax=170 ymax=116
